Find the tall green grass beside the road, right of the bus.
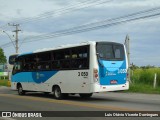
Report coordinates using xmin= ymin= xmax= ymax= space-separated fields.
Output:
xmin=128 ymin=68 xmax=160 ymax=94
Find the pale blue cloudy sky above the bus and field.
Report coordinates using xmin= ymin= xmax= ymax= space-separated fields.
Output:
xmin=0 ymin=0 xmax=160 ymax=67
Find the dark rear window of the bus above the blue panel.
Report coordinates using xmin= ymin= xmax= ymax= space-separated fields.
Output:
xmin=97 ymin=42 xmax=124 ymax=61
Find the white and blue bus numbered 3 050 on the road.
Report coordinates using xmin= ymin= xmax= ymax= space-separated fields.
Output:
xmin=9 ymin=41 xmax=129 ymax=99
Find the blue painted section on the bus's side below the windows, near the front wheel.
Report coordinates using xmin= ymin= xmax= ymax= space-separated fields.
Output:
xmin=12 ymin=71 xmax=58 ymax=83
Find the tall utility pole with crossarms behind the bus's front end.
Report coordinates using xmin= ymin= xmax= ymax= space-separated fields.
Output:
xmin=8 ymin=23 xmax=21 ymax=53
